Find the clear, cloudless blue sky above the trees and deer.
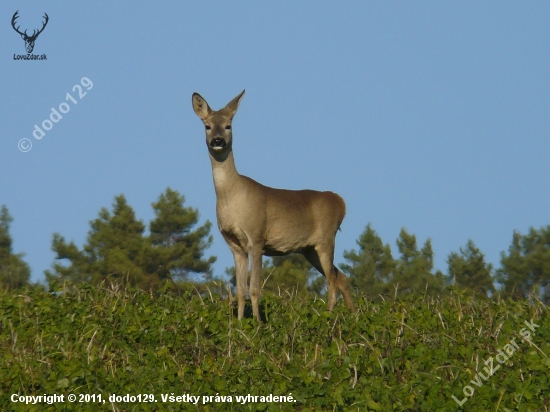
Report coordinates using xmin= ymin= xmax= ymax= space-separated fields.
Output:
xmin=0 ymin=1 xmax=550 ymax=280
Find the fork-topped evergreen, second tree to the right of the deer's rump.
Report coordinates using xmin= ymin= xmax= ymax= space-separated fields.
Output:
xmin=392 ymin=229 xmax=445 ymax=295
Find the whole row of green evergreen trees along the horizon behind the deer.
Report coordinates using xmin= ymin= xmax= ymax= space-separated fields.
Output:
xmin=0 ymin=188 xmax=550 ymax=302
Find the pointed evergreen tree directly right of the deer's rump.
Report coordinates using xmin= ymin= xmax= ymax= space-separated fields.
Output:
xmin=340 ymin=223 xmax=395 ymax=297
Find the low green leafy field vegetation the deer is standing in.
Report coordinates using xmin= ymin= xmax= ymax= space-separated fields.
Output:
xmin=0 ymin=283 xmax=550 ymax=412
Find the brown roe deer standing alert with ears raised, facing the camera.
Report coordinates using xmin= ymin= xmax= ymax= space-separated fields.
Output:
xmin=192 ymin=90 xmax=355 ymax=322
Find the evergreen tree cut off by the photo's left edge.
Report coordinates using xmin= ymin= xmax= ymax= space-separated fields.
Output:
xmin=0 ymin=205 xmax=31 ymax=288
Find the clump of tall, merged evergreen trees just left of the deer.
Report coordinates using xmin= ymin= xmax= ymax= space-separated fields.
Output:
xmin=45 ymin=189 xmax=215 ymax=289
